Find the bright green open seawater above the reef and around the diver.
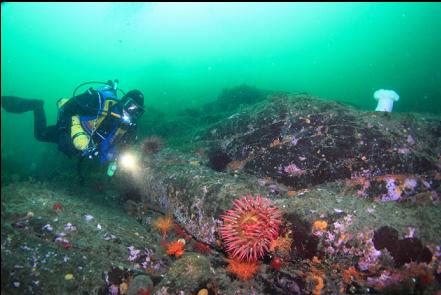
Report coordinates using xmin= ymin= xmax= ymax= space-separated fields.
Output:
xmin=1 ymin=3 xmax=441 ymax=178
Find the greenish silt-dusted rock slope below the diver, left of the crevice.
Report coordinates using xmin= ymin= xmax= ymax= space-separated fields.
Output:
xmin=1 ymin=180 xmax=160 ymax=294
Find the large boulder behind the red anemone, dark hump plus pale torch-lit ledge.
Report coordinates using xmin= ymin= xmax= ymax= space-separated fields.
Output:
xmin=125 ymin=95 xmax=441 ymax=246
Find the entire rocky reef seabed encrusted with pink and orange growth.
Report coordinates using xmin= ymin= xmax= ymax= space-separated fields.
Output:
xmin=2 ymin=85 xmax=441 ymax=294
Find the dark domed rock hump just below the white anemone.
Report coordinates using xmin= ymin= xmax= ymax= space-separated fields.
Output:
xmin=202 ymin=95 xmax=441 ymax=189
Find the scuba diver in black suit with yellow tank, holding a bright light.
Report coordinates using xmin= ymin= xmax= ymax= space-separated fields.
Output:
xmin=1 ymin=80 xmax=144 ymax=183
